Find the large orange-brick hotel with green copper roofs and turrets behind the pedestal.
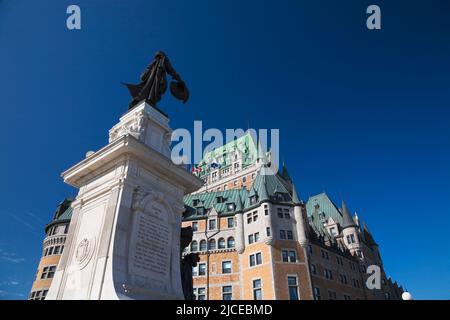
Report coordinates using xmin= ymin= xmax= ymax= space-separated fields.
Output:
xmin=29 ymin=134 xmax=403 ymax=300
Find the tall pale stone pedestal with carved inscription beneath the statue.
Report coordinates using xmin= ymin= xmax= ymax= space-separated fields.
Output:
xmin=47 ymin=103 xmax=203 ymax=300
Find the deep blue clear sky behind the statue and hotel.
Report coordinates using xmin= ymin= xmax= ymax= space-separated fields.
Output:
xmin=0 ymin=0 xmax=450 ymax=299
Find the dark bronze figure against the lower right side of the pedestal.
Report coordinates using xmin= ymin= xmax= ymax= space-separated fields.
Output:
xmin=180 ymin=227 xmax=200 ymax=300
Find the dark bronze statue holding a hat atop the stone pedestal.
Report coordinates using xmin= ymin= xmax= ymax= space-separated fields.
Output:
xmin=124 ymin=51 xmax=189 ymax=110
